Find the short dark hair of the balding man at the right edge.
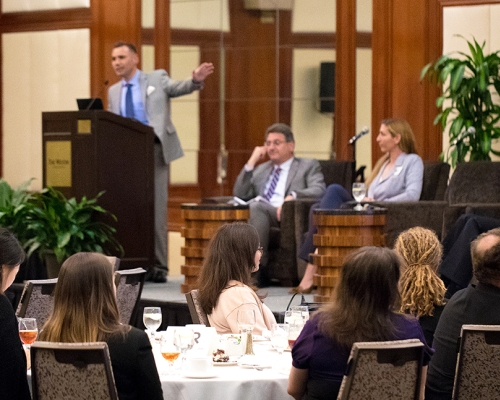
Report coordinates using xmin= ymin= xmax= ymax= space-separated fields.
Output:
xmin=471 ymin=228 xmax=500 ymax=283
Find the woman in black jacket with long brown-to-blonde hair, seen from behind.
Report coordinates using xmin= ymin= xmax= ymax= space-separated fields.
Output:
xmin=39 ymin=253 xmax=163 ymax=400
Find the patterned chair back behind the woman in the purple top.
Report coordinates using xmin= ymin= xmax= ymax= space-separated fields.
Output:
xmin=337 ymin=339 xmax=424 ymax=400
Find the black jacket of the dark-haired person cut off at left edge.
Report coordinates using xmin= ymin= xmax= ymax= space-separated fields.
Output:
xmin=0 ymin=294 xmax=31 ymax=400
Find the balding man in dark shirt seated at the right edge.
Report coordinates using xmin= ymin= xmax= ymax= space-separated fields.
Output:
xmin=425 ymin=228 xmax=500 ymax=400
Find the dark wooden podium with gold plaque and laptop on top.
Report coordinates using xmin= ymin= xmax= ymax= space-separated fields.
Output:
xmin=42 ymin=110 xmax=155 ymax=269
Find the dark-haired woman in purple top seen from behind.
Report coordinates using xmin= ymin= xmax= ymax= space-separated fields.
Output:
xmin=288 ymin=247 xmax=432 ymax=400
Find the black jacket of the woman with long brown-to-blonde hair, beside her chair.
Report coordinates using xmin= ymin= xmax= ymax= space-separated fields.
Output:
xmin=107 ymin=328 xmax=163 ymax=400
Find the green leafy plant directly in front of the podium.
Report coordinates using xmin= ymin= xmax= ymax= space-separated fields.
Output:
xmin=26 ymin=187 xmax=123 ymax=262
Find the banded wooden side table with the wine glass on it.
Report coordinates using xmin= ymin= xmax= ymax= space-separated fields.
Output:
xmin=310 ymin=208 xmax=387 ymax=302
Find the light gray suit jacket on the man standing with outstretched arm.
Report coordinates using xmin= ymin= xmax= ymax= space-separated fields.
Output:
xmin=108 ymin=69 xmax=203 ymax=163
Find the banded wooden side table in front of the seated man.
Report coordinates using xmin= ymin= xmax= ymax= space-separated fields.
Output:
xmin=181 ymin=203 xmax=250 ymax=293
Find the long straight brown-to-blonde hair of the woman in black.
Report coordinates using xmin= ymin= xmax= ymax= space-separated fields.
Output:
xmin=40 ymin=253 xmax=130 ymax=343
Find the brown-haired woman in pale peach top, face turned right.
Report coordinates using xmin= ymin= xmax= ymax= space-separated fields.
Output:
xmin=198 ymin=222 xmax=276 ymax=334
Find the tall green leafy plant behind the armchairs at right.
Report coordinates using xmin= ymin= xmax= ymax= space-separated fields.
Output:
xmin=421 ymin=35 xmax=500 ymax=166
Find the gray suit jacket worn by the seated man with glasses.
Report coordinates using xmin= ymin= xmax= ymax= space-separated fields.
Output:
xmin=233 ymin=157 xmax=325 ymax=200
